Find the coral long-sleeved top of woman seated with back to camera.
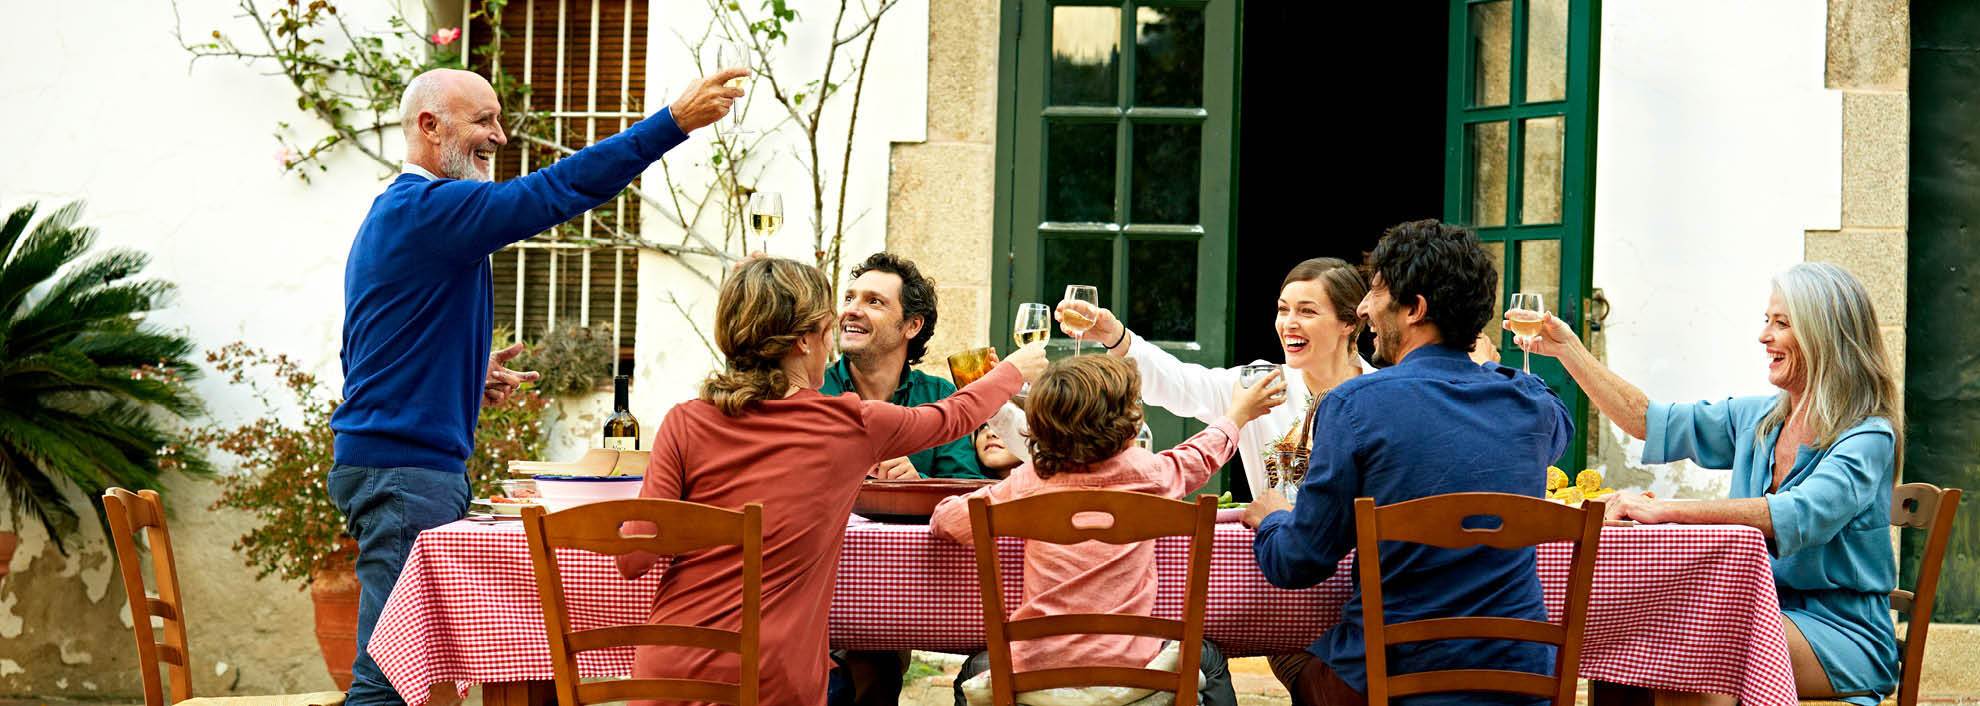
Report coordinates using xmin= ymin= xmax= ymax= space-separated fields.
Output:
xmin=620 ymin=364 xmax=1024 ymax=706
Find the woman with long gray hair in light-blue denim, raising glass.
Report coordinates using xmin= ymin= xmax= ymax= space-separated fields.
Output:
xmin=1515 ymin=263 xmax=1903 ymax=706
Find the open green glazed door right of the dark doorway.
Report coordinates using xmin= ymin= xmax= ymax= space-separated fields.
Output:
xmin=1443 ymin=0 xmax=1600 ymax=466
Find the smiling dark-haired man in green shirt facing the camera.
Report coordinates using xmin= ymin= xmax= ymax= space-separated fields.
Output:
xmin=818 ymin=253 xmax=984 ymax=479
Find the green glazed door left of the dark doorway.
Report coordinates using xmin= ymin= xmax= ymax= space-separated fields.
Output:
xmin=990 ymin=0 xmax=1238 ymax=485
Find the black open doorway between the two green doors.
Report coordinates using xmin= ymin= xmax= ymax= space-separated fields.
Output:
xmin=1230 ymin=0 xmax=1449 ymax=364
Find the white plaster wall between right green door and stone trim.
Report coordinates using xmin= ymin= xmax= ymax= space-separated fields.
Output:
xmin=1594 ymin=0 xmax=1841 ymax=494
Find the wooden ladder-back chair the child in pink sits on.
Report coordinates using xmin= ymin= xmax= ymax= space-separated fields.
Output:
xmin=970 ymin=490 xmax=1218 ymax=706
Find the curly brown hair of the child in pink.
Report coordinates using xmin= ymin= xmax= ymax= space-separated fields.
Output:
xmin=1026 ymin=356 xmax=1140 ymax=479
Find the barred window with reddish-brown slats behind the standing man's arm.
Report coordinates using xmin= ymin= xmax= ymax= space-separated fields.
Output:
xmin=461 ymin=0 xmax=647 ymax=359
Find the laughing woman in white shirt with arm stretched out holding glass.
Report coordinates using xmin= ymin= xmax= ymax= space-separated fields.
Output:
xmin=1055 ymin=257 xmax=1374 ymax=496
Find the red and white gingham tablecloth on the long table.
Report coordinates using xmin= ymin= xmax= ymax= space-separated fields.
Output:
xmin=370 ymin=518 xmax=1796 ymax=706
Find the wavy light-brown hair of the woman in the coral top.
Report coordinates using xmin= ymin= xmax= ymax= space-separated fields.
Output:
xmin=701 ymin=257 xmax=834 ymax=417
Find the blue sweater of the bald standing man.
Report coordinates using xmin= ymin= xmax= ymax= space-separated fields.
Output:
xmin=331 ymin=111 xmax=687 ymax=473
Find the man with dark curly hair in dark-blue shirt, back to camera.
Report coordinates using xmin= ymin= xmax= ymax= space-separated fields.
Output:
xmin=1243 ymin=220 xmax=1574 ymax=706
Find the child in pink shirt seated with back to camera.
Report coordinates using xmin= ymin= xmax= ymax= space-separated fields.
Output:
xmin=929 ymin=356 xmax=1285 ymax=706
